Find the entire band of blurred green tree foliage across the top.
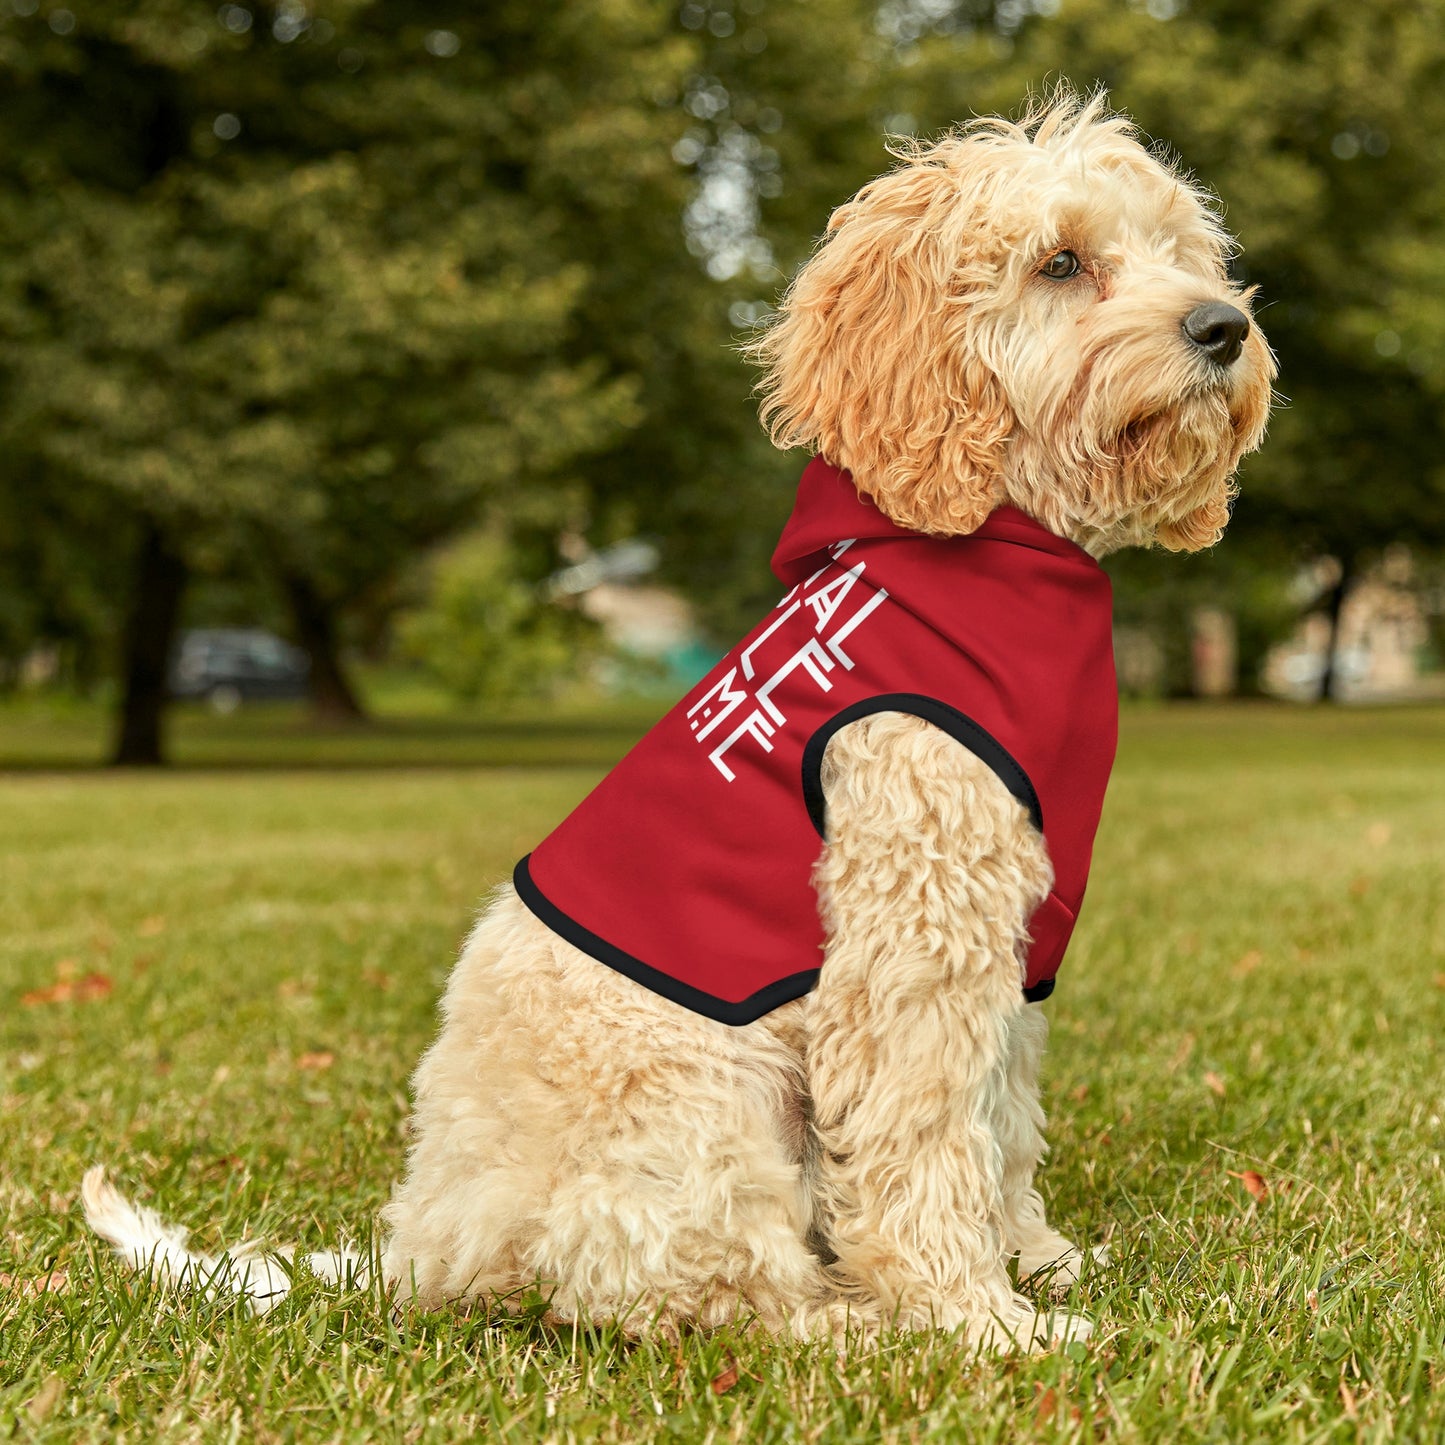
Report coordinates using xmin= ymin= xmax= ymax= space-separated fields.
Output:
xmin=0 ymin=0 xmax=1445 ymax=699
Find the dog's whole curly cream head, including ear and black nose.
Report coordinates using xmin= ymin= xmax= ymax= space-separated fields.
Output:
xmin=751 ymin=91 xmax=1274 ymax=553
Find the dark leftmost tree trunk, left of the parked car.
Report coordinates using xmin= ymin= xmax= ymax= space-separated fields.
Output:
xmin=111 ymin=522 xmax=186 ymax=767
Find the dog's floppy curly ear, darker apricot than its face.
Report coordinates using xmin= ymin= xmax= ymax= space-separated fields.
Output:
xmin=749 ymin=151 xmax=1013 ymax=535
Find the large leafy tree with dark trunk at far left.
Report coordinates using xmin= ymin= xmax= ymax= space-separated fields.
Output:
xmin=0 ymin=0 xmax=689 ymax=763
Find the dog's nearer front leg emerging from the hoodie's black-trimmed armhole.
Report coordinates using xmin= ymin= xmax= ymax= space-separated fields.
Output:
xmin=808 ymin=714 xmax=1088 ymax=1345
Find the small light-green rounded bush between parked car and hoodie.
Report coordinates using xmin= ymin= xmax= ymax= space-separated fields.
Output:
xmin=397 ymin=532 xmax=597 ymax=702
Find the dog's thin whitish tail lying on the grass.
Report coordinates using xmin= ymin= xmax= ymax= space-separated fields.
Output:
xmin=81 ymin=1165 xmax=370 ymax=1315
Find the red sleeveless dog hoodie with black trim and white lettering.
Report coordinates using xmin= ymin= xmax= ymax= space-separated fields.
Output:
xmin=514 ymin=458 xmax=1118 ymax=1025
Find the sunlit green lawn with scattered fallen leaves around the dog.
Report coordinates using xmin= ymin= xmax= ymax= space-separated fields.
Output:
xmin=0 ymin=707 xmax=1445 ymax=1442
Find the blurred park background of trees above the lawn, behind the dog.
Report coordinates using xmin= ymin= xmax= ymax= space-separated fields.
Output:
xmin=0 ymin=0 xmax=1445 ymax=764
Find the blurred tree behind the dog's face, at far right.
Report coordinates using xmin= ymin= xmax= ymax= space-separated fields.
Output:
xmin=892 ymin=0 xmax=1445 ymax=688
